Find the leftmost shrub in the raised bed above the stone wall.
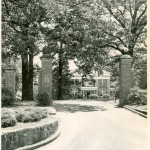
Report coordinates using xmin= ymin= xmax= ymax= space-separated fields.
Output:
xmin=1 ymin=110 xmax=17 ymax=128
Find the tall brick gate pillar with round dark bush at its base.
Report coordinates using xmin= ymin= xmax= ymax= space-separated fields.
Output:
xmin=39 ymin=54 xmax=52 ymax=100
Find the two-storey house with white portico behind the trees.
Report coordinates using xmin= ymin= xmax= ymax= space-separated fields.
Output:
xmin=71 ymin=71 xmax=115 ymax=98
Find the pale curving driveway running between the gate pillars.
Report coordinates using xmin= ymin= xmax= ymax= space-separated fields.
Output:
xmin=37 ymin=100 xmax=147 ymax=150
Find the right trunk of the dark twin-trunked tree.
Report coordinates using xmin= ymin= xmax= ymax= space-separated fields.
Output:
xmin=28 ymin=53 xmax=34 ymax=100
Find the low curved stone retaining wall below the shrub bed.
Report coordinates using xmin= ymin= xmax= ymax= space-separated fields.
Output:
xmin=1 ymin=120 xmax=58 ymax=150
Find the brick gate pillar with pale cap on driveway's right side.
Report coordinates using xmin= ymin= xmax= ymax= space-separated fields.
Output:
xmin=119 ymin=55 xmax=132 ymax=104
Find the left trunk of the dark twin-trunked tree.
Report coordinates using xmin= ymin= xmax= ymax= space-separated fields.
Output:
xmin=22 ymin=54 xmax=28 ymax=100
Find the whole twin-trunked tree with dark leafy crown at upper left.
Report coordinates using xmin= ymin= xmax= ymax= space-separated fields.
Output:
xmin=2 ymin=0 xmax=47 ymax=100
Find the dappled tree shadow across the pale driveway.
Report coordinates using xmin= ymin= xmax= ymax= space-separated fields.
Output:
xmin=54 ymin=104 xmax=107 ymax=113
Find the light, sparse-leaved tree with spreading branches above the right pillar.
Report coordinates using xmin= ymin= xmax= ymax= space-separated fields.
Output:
xmin=97 ymin=0 xmax=147 ymax=56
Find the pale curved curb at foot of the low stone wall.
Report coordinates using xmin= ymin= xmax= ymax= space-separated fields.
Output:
xmin=16 ymin=128 xmax=61 ymax=150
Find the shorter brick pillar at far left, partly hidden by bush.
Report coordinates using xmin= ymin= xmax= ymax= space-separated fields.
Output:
xmin=5 ymin=65 xmax=16 ymax=99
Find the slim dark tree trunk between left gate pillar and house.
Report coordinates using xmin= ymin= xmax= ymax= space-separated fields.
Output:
xmin=57 ymin=46 xmax=63 ymax=100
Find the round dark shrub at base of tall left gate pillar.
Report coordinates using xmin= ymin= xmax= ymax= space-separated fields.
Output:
xmin=36 ymin=92 xmax=52 ymax=106
